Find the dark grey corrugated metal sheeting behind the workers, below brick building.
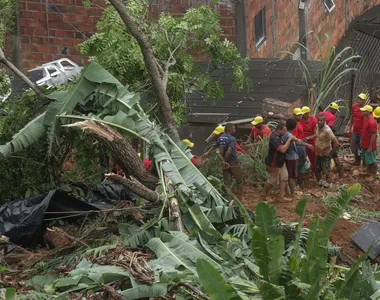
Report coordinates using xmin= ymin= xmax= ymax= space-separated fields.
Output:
xmin=186 ymin=59 xmax=323 ymax=123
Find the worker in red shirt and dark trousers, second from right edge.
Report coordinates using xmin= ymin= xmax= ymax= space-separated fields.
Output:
xmin=349 ymin=93 xmax=367 ymax=166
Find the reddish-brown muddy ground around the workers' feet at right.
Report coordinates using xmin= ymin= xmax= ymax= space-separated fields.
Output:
xmin=241 ymin=163 xmax=380 ymax=265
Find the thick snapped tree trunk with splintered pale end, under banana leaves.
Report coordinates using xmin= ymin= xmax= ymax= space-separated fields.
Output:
xmin=70 ymin=121 xmax=158 ymax=190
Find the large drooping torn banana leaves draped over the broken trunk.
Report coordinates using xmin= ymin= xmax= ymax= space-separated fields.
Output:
xmin=0 ymin=62 xmax=232 ymax=234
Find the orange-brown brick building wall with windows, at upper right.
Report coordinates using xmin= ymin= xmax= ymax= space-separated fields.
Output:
xmin=246 ymin=0 xmax=380 ymax=58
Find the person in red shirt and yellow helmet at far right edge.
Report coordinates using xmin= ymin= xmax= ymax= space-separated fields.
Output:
xmin=360 ymin=105 xmax=377 ymax=175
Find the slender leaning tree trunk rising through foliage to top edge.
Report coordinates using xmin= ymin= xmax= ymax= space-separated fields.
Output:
xmin=106 ymin=0 xmax=179 ymax=141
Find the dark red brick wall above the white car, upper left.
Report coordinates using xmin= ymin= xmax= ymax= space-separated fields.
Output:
xmin=19 ymin=0 xmax=105 ymax=70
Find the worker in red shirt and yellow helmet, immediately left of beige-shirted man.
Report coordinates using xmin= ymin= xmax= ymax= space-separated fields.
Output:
xmin=300 ymin=106 xmax=318 ymax=173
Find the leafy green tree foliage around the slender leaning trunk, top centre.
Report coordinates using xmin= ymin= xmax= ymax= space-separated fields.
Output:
xmin=79 ymin=0 xmax=248 ymax=124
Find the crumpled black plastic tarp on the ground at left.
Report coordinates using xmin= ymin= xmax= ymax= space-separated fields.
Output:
xmin=0 ymin=182 xmax=135 ymax=248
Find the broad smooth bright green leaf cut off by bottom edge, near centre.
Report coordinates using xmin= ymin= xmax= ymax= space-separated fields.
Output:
xmin=197 ymin=259 xmax=237 ymax=300
